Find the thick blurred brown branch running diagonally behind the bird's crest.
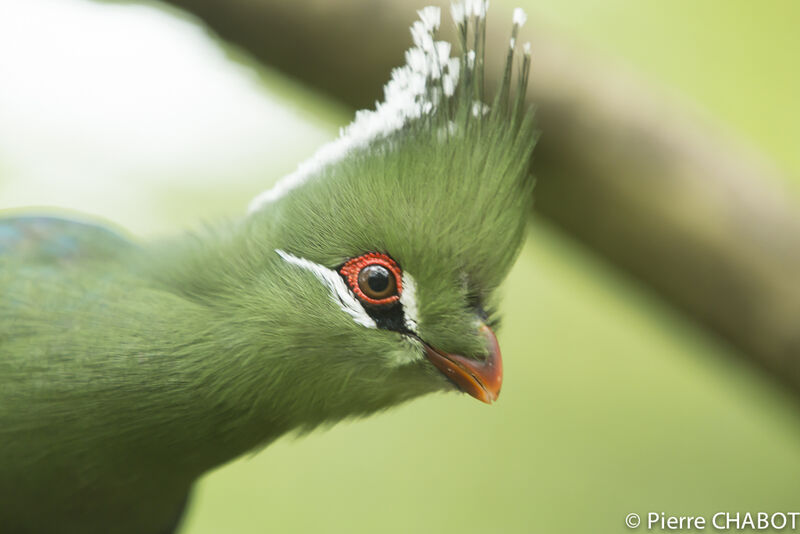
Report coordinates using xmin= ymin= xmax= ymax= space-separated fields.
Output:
xmin=156 ymin=0 xmax=800 ymax=389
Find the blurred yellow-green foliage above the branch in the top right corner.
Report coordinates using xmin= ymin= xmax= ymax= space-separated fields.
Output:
xmin=506 ymin=0 xmax=800 ymax=194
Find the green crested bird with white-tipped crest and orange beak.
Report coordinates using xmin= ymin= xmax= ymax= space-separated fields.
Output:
xmin=0 ymin=0 xmax=538 ymax=534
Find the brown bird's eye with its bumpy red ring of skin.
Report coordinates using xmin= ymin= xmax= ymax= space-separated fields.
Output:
xmin=339 ymin=252 xmax=402 ymax=306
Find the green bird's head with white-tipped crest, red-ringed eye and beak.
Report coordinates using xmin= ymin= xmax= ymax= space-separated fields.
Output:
xmin=241 ymin=1 xmax=535 ymax=426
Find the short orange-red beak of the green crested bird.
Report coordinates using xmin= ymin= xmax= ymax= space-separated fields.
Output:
xmin=424 ymin=325 xmax=503 ymax=404
